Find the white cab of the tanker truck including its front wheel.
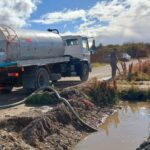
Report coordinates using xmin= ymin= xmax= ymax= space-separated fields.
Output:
xmin=62 ymin=35 xmax=92 ymax=81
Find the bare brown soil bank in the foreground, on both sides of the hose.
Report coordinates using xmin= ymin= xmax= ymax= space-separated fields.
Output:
xmin=0 ymin=92 xmax=114 ymax=150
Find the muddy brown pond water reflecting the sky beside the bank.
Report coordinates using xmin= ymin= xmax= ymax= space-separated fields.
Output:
xmin=73 ymin=102 xmax=150 ymax=150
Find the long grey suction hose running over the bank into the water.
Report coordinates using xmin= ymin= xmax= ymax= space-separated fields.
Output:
xmin=0 ymin=87 xmax=98 ymax=132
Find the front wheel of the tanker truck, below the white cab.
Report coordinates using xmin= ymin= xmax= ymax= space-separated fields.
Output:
xmin=80 ymin=63 xmax=89 ymax=81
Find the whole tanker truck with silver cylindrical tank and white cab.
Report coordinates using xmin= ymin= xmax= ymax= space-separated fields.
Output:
xmin=0 ymin=25 xmax=95 ymax=91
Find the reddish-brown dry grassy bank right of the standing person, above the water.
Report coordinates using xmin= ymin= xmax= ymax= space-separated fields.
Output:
xmin=117 ymin=60 xmax=150 ymax=101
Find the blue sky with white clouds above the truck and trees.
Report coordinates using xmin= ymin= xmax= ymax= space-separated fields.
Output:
xmin=0 ymin=0 xmax=150 ymax=44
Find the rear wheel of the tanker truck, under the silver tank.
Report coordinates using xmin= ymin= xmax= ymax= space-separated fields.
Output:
xmin=35 ymin=68 xmax=49 ymax=89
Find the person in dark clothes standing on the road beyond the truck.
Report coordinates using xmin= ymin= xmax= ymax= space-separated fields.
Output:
xmin=110 ymin=49 xmax=118 ymax=79
